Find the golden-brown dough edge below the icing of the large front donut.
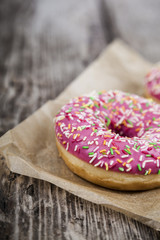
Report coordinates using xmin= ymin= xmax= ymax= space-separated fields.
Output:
xmin=56 ymin=138 xmax=160 ymax=191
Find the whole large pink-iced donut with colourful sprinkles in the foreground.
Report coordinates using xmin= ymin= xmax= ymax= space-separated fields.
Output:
xmin=54 ymin=90 xmax=160 ymax=191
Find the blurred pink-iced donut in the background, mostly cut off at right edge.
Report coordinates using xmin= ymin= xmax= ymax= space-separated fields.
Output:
xmin=145 ymin=68 xmax=160 ymax=103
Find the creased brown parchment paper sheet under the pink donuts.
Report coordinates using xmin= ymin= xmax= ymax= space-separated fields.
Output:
xmin=0 ymin=40 xmax=160 ymax=230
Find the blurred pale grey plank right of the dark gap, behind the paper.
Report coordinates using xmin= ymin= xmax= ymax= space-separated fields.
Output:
xmin=103 ymin=0 xmax=160 ymax=62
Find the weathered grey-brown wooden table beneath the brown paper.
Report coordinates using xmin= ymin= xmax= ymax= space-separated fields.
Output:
xmin=0 ymin=0 xmax=160 ymax=240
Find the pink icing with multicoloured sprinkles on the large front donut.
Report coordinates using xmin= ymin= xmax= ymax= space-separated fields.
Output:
xmin=55 ymin=91 xmax=160 ymax=175
